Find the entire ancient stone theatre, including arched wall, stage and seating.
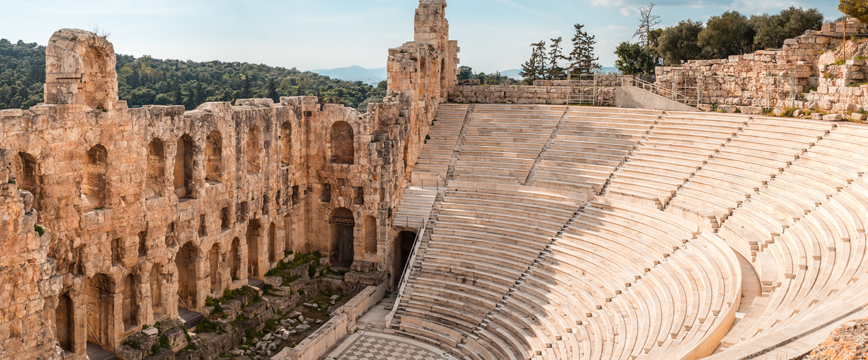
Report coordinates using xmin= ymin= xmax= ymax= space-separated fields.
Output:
xmin=0 ymin=0 xmax=868 ymax=360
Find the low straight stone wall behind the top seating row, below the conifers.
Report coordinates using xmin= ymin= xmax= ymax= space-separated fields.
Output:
xmin=449 ymin=84 xmax=620 ymax=106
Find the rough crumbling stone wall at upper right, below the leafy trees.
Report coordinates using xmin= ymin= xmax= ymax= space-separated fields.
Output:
xmin=656 ymin=21 xmax=868 ymax=108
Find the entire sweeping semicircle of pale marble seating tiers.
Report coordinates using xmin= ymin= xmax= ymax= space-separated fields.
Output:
xmin=391 ymin=104 xmax=868 ymax=359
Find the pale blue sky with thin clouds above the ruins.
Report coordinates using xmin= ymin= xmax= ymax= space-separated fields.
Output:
xmin=0 ymin=0 xmax=841 ymax=72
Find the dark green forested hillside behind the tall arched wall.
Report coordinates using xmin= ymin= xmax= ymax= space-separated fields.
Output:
xmin=0 ymin=39 xmax=386 ymax=111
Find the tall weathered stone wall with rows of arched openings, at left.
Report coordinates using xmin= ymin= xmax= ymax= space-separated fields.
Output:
xmin=0 ymin=0 xmax=458 ymax=359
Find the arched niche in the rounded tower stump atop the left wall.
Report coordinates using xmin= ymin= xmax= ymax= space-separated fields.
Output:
xmin=81 ymin=46 xmax=117 ymax=109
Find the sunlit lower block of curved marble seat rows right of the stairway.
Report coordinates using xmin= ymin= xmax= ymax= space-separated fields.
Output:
xmin=464 ymin=199 xmax=741 ymax=359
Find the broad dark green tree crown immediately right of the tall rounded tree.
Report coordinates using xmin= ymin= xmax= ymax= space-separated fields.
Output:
xmin=749 ymin=6 xmax=823 ymax=49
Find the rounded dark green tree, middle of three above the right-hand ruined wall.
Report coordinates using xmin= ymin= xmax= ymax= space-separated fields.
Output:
xmin=697 ymin=11 xmax=755 ymax=59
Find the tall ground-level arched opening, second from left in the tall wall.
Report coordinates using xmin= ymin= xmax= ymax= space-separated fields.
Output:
xmin=85 ymin=274 xmax=114 ymax=350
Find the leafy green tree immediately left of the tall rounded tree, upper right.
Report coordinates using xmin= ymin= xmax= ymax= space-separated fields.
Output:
xmin=657 ymin=19 xmax=702 ymax=65
